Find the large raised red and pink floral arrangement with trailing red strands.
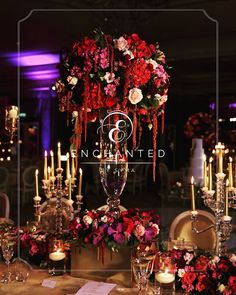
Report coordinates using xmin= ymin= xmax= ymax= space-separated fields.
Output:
xmin=55 ymin=31 xmax=169 ymax=180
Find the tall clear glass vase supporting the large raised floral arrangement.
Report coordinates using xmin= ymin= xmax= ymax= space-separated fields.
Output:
xmin=99 ymin=111 xmax=132 ymax=216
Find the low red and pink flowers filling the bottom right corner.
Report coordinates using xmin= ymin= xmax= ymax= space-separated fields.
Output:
xmin=171 ymin=250 xmax=236 ymax=295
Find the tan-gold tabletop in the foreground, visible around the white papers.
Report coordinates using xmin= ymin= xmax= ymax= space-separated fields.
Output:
xmin=0 ymin=265 xmax=183 ymax=295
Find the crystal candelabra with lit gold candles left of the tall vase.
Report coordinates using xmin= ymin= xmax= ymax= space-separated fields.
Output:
xmin=34 ymin=143 xmax=83 ymax=235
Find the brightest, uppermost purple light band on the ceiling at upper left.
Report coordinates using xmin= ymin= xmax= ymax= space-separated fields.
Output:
xmin=9 ymin=51 xmax=59 ymax=67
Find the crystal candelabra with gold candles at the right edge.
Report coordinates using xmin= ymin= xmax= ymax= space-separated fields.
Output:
xmin=191 ymin=142 xmax=236 ymax=256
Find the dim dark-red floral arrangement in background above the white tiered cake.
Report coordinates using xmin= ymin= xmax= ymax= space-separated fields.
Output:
xmin=184 ymin=112 xmax=215 ymax=147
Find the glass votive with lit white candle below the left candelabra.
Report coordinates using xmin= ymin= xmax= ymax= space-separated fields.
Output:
xmin=48 ymin=239 xmax=66 ymax=276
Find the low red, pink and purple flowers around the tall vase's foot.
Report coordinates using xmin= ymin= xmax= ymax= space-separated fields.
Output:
xmin=70 ymin=208 xmax=160 ymax=251
